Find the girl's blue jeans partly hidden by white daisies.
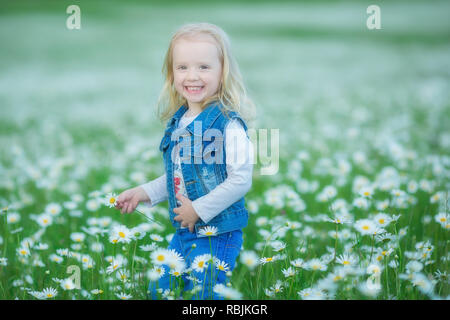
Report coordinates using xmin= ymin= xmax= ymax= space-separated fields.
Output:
xmin=148 ymin=229 xmax=242 ymax=300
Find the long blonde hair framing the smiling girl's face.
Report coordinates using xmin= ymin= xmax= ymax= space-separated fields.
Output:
xmin=157 ymin=23 xmax=255 ymax=122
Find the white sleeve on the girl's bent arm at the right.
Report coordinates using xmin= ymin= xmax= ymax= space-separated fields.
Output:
xmin=192 ymin=119 xmax=253 ymax=223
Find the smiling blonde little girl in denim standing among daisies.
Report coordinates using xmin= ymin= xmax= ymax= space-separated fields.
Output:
xmin=117 ymin=23 xmax=254 ymax=299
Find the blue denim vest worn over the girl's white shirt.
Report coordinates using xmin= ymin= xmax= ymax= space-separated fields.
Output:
xmin=159 ymin=102 xmax=248 ymax=237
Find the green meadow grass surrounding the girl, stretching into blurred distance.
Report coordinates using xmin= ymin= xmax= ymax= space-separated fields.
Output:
xmin=0 ymin=1 xmax=450 ymax=300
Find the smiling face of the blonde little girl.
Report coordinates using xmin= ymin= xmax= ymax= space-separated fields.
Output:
xmin=173 ymin=35 xmax=222 ymax=111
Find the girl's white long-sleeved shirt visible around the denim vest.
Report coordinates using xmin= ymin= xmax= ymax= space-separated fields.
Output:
xmin=141 ymin=113 xmax=253 ymax=223
